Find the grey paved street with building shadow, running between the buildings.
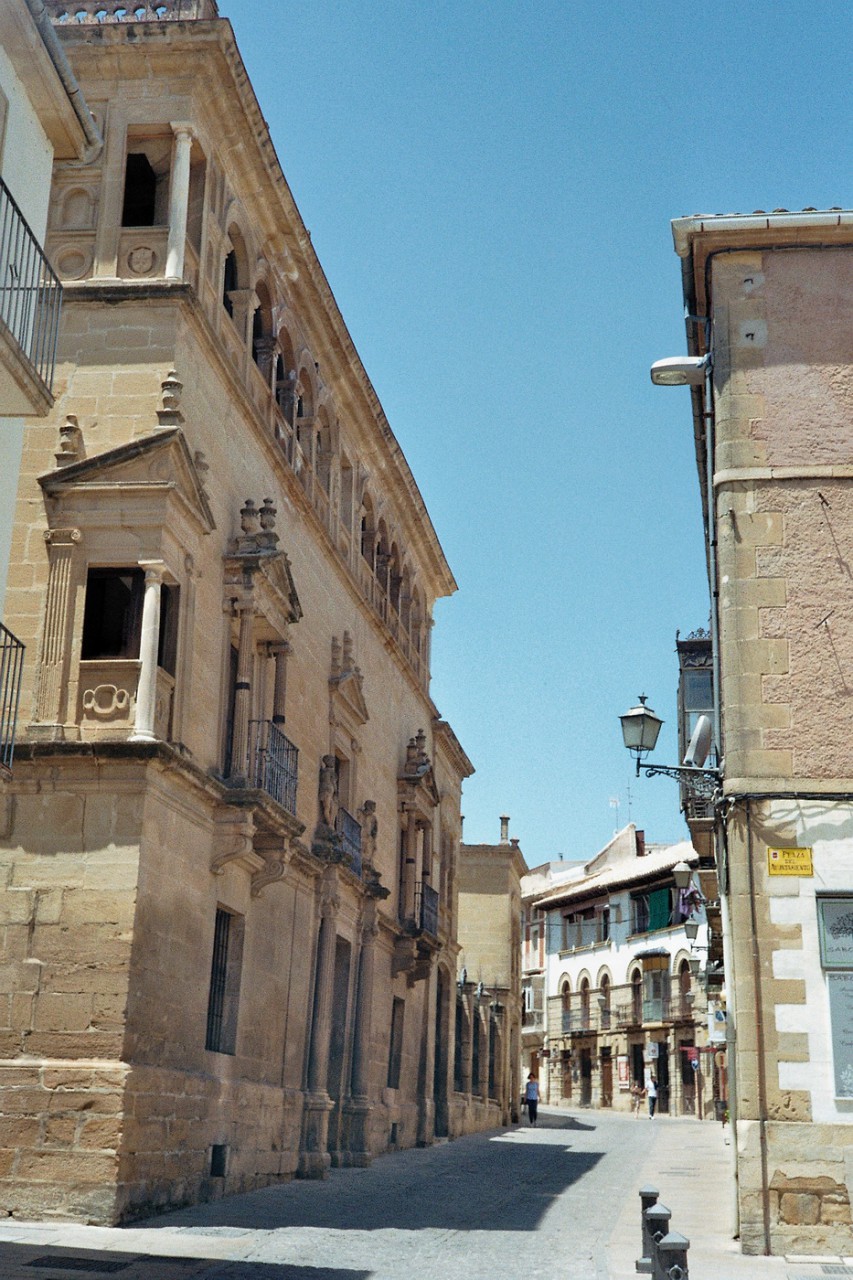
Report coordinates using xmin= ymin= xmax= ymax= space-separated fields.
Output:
xmin=0 ymin=1111 xmax=804 ymax=1280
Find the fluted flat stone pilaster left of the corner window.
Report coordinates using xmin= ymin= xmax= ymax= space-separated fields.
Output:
xmin=31 ymin=529 xmax=83 ymax=740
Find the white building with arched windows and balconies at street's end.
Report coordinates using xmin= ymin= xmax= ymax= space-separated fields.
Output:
xmin=532 ymin=824 xmax=725 ymax=1116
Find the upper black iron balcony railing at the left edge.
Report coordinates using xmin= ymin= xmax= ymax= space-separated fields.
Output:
xmin=0 ymin=178 xmax=63 ymax=390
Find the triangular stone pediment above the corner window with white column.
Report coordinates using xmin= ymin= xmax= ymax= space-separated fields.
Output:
xmin=38 ymin=428 xmax=216 ymax=534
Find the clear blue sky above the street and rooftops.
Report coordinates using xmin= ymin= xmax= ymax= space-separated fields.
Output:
xmin=220 ymin=0 xmax=853 ymax=865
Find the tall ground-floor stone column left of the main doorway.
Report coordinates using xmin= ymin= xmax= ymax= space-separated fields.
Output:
xmin=298 ymin=867 xmax=339 ymax=1178
